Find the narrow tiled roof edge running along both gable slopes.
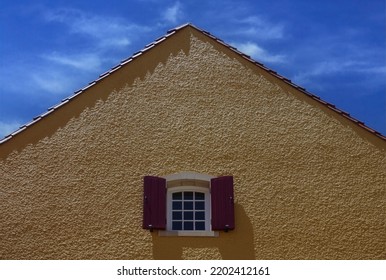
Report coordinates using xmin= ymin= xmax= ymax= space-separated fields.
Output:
xmin=0 ymin=22 xmax=386 ymax=145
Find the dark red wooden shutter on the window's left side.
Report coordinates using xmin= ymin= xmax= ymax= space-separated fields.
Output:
xmin=142 ymin=176 xmax=166 ymax=230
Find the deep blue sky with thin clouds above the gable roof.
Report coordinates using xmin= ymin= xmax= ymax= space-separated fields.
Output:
xmin=0 ymin=0 xmax=386 ymax=138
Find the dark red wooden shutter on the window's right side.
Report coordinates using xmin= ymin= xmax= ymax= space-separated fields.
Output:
xmin=210 ymin=176 xmax=235 ymax=231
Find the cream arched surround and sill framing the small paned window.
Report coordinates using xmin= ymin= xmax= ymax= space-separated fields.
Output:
xmin=158 ymin=172 xmax=218 ymax=237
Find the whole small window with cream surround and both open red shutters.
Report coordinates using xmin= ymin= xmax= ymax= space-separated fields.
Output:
xmin=143 ymin=172 xmax=234 ymax=236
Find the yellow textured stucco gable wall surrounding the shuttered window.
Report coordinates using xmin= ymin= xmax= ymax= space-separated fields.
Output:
xmin=0 ymin=27 xmax=386 ymax=259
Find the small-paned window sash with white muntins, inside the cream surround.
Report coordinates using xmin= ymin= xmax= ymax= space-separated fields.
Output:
xmin=171 ymin=191 xmax=206 ymax=231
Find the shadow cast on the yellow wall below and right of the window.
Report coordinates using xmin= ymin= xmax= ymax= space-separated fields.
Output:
xmin=152 ymin=204 xmax=255 ymax=260
